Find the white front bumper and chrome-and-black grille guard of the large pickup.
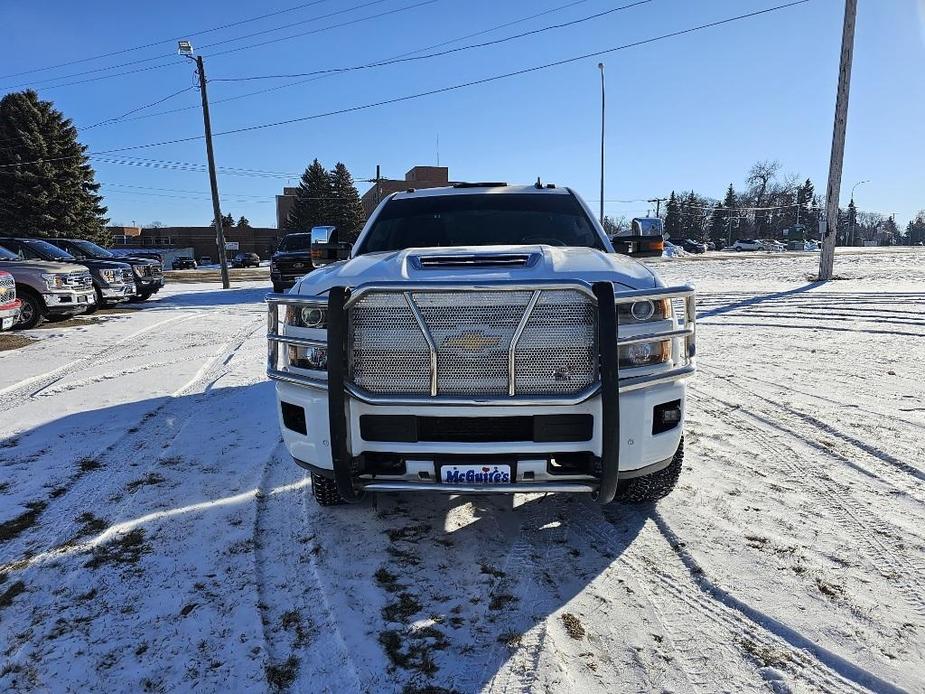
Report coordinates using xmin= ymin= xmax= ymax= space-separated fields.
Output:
xmin=267 ymin=282 xmax=695 ymax=503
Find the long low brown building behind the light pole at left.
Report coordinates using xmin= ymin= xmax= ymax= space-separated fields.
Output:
xmin=109 ymin=226 xmax=284 ymax=260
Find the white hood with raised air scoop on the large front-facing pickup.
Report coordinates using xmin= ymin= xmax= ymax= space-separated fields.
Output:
xmin=293 ymin=246 xmax=661 ymax=294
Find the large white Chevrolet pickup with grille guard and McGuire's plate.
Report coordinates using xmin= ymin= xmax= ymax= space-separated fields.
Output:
xmin=267 ymin=182 xmax=695 ymax=506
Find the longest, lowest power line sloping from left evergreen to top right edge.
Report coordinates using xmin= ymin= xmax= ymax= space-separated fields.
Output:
xmin=0 ymin=0 xmax=810 ymax=168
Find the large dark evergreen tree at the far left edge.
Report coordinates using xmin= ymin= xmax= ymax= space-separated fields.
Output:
xmin=0 ymin=89 xmax=109 ymax=242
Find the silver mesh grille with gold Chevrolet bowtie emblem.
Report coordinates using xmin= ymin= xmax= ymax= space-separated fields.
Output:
xmin=349 ymin=289 xmax=598 ymax=397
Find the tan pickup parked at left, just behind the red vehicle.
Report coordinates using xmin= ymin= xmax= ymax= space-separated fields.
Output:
xmin=0 ymin=245 xmax=96 ymax=329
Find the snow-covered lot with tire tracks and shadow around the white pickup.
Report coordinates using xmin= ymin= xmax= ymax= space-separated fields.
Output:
xmin=0 ymin=250 xmax=925 ymax=692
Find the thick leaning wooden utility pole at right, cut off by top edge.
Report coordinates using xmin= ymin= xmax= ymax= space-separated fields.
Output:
xmin=819 ymin=0 xmax=858 ymax=281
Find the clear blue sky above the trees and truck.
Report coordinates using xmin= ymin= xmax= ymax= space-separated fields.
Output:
xmin=0 ymin=0 xmax=925 ymax=226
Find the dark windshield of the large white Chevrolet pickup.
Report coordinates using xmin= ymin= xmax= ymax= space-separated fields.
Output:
xmin=357 ymin=193 xmax=606 ymax=255
